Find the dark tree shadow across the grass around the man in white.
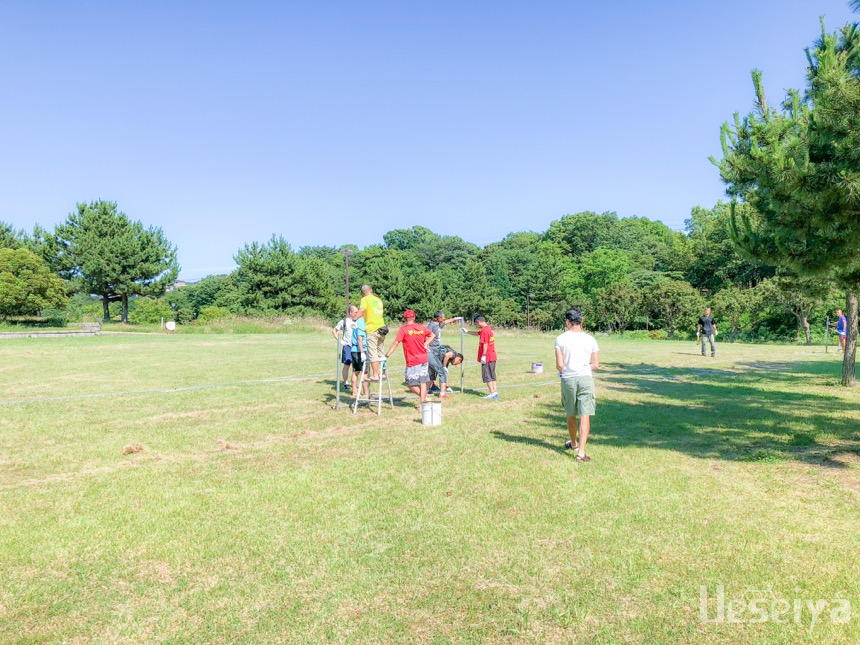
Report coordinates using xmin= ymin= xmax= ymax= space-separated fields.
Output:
xmin=493 ymin=361 xmax=860 ymax=468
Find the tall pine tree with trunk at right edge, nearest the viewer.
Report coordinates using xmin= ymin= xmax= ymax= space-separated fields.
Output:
xmin=712 ymin=21 xmax=860 ymax=385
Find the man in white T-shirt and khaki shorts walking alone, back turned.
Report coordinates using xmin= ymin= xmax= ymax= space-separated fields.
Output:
xmin=555 ymin=307 xmax=600 ymax=462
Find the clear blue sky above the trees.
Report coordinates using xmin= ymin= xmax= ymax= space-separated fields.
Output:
xmin=0 ymin=0 xmax=860 ymax=279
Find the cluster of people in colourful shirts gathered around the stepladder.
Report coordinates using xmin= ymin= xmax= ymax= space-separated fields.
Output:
xmin=332 ymin=284 xmax=499 ymax=403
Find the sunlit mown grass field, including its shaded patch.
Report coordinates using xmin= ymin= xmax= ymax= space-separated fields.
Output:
xmin=0 ymin=332 xmax=860 ymax=643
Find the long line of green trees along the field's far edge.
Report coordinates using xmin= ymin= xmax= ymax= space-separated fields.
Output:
xmin=0 ymin=201 xmax=839 ymax=342
